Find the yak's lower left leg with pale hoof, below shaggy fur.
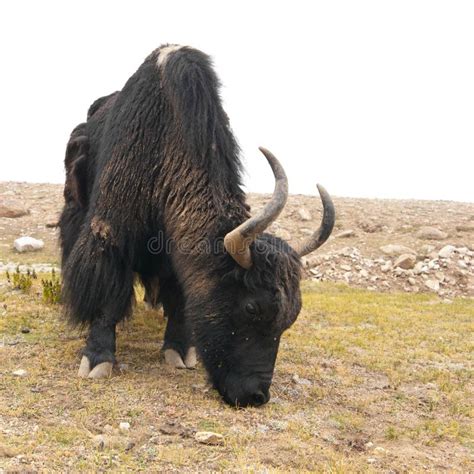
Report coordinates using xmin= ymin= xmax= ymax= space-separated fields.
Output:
xmin=78 ymin=317 xmax=116 ymax=378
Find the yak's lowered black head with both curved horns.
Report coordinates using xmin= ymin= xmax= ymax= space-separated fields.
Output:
xmin=189 ymin=148 xmax=335 ymax=406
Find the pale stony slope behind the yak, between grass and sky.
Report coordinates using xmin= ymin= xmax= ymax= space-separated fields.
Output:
xmin=0 ymin=182 xmax=474 ymax=298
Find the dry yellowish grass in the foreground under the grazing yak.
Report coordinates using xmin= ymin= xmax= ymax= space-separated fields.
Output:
xmin=0 ymin=275 xmax=474 ymax=473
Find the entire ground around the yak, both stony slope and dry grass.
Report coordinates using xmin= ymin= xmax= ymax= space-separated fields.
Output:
xmin=0 ymin=183 xmax=474 ymax=473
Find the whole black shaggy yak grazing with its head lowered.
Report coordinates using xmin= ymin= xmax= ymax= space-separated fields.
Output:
xmin=59 ymin=45 xmax=335 ymax=406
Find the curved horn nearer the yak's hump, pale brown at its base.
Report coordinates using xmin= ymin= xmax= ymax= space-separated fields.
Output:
xmin=224 ymin=147 xmax=288 ymax=270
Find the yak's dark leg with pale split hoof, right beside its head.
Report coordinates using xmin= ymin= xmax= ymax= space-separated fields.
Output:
xmin=160 ymin=277 xmax=197 ymax=369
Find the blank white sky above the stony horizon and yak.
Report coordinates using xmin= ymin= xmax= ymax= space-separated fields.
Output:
xmin=0 ymin=0 xmax=474 ymax=202
